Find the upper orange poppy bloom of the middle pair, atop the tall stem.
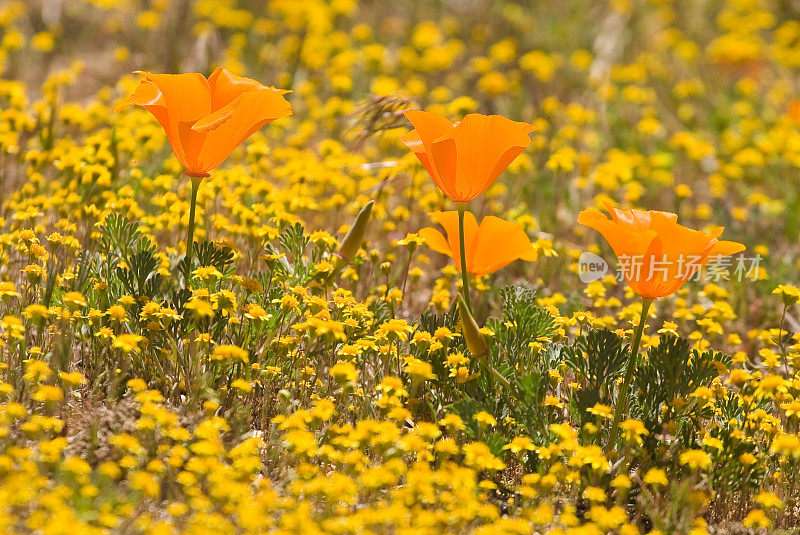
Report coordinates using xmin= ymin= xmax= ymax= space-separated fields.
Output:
xmin=400 ymin=110 xmax=534 ymax=202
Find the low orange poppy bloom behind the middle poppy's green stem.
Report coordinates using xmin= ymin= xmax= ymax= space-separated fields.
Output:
xmin=419 ymin=210 xmax=539 ymax=276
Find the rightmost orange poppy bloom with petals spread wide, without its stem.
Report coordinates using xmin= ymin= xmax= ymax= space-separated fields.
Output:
xmin=578 ymin=205 xmax=745 ymax=299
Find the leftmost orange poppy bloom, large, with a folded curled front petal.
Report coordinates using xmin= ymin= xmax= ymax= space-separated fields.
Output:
xmin=115 ymin=68 xmax=292 ymax=177
